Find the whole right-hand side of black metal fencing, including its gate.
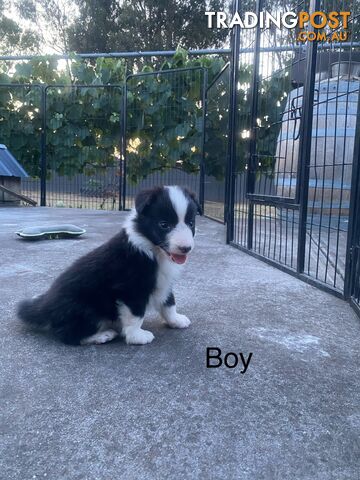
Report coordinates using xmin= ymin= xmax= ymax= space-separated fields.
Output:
xmin=227 ymin=0 xmax=360 ymax=302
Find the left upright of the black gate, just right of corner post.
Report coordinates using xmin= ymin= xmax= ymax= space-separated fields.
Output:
xmin=246 ymin=0 xmax=262 ymax=250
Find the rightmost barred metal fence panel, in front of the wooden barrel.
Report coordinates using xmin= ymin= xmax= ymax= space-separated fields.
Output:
xmin=304 ymin=2 xmax=360 ymax=291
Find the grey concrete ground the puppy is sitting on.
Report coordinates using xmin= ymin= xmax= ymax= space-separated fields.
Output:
xmin=0 ymin=208 xmax=360 ymax=480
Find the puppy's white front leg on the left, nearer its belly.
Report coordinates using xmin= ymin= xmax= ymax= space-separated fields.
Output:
xmin=119 ymin=304 xmax=155 ymax=345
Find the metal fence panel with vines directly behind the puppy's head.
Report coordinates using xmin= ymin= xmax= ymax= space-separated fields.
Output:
xmin=122 ymin=67 xmax=206 ymax=209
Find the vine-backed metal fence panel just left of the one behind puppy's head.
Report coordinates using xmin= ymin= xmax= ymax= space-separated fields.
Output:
xmin=45 ymin=85 xmax=123 ymax=210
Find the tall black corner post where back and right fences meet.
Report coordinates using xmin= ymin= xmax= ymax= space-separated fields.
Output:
xmin=226 ymin=0 xmax=240 ymax=243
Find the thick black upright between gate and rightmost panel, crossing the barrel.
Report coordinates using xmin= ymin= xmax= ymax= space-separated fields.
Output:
xmin=296 ymin=0 xmax=320 ymax=273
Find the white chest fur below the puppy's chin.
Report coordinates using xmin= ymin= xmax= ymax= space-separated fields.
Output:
xmin=150 ymin=252 xmax=183 ymax=309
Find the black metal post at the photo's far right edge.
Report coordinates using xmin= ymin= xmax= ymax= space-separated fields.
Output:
xmin=344 ymin=92 xmax=360 ymax=298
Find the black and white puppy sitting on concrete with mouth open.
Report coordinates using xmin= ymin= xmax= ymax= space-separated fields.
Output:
xmin=18 ymin=186 xmax=201 ymax=345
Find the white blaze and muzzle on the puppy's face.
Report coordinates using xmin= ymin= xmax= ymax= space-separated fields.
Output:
xmin=165 ymin=186 xmax=194 ymax=254
